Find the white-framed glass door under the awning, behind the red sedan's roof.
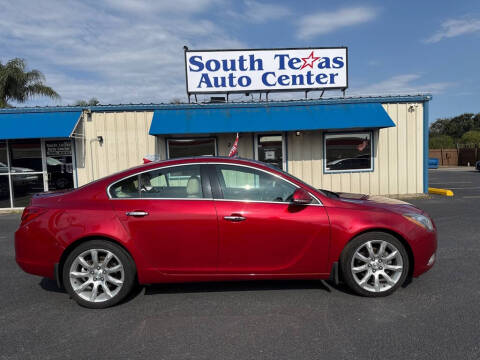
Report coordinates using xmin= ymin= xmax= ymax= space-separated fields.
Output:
xmin=255 ymin=134 xmax=286 ymax=171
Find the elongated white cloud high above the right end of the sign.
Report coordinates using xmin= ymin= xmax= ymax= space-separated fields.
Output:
xmin=297 ymin=6 xmax=378 ymax=39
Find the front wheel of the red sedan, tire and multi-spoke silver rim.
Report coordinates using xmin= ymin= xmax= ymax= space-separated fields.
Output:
xmin=340 ymin=232 xmax=410 ymax=297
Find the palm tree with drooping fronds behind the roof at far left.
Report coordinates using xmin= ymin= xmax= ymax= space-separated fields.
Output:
xmin=0 ymin=58 xmax=60 ymax=108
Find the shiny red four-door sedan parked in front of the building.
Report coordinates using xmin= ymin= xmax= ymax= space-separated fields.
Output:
xmin=15 ymin=158 xmax=437 ymax=308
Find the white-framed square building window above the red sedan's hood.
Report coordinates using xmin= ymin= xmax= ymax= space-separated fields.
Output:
xmin=324 ymin=132 xmax=373 ymax=173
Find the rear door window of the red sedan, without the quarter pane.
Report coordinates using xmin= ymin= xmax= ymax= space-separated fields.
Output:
xmin=140 ymin=165 xmax=204 ymax=199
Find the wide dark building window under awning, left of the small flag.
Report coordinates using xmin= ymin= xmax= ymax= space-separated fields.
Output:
xmin=167 ymin=138 xmax=217 ymax=159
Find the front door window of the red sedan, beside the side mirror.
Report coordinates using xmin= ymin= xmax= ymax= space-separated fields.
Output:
xmin=216 ymin=165 xmax=296 ymax=202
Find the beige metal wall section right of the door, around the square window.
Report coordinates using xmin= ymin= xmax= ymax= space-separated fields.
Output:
xmin=287 ymin=103 xmax=423 ymax=195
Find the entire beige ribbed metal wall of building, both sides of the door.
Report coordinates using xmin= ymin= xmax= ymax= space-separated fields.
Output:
xmin=76 ymin=103 xmax=423 ymax=195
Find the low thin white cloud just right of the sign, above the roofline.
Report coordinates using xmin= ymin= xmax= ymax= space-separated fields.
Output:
xmin=348 ymin=74 xmax=454 ymax=95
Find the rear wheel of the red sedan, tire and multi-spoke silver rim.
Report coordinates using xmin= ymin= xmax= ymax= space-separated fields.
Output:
xmin=62 ymin=240 xmax=136 ymax=309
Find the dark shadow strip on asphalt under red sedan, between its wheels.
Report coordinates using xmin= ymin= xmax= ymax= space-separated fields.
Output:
xmin=145 ymin=280 xmax=331 ymax=295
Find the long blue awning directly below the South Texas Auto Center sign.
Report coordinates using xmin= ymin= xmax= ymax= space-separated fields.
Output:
xmin=150 ymin=103 xmax=395 ymax=135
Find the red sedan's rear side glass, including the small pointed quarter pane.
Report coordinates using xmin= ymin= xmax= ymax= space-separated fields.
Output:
xmin=110 ymin=165 xmax=203 ymax=199
